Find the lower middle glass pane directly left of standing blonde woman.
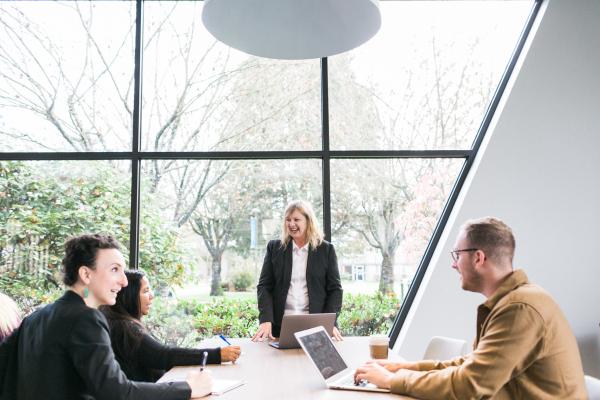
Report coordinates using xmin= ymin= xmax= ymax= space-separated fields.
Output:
xmin=140 ymin=160 xmax=322 ymax=345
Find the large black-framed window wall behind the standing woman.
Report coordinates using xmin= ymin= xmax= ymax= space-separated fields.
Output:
xmin=0 ymin=0 xmax=540 ymax=345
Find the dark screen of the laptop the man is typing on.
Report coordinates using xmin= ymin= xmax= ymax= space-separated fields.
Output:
xmin=298 ymin=330 xmax=348 ymax=379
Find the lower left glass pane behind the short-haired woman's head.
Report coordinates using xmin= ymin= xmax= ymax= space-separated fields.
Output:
xmin=0 ymin=161 xmax=131 ymax=312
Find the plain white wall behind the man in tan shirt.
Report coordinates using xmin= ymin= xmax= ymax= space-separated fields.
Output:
xmin=396 ymin=0 xmax=600 ymax=376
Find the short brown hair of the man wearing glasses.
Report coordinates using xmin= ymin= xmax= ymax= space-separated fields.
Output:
xmin=462 ymin=217 xmax=515 ymax=264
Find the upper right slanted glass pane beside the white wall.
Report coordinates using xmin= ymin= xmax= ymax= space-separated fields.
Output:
xmin=329 ymin=1 xmax=532 ymax=150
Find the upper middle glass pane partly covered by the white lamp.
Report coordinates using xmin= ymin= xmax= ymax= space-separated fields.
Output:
xmin=142 ymin=1 xmax=321 ymax=151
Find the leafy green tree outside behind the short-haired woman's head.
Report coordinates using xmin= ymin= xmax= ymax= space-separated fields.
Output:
xmin=0 ymin=161 xmax=184 ymax=305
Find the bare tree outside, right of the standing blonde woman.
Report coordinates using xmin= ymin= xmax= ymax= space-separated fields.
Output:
xmin=330 ymin=36 xmax=493 ymax=293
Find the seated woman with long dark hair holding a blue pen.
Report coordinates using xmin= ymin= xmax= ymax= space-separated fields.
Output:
xmin=101 ymin=270 xmax=240 ymax=382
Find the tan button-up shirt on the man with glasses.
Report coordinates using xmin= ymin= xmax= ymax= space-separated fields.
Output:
xmin=392 ymin=270 xmax=587 ymax=400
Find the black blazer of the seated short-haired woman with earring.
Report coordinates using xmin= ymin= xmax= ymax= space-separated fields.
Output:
xmin=13 ymin=291 xmax=191 ymax=400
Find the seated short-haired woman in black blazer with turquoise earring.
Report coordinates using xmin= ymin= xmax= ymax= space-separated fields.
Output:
xmin=5 ymin=235 xmax=212 ymax=400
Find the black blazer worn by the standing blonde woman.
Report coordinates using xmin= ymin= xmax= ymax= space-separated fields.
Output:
xmin=256 ymin=240 xmax=343 ymax=336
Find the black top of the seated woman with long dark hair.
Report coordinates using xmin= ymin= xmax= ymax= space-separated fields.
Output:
xmin=106 ymin=314 xmax=221 ymax=382
